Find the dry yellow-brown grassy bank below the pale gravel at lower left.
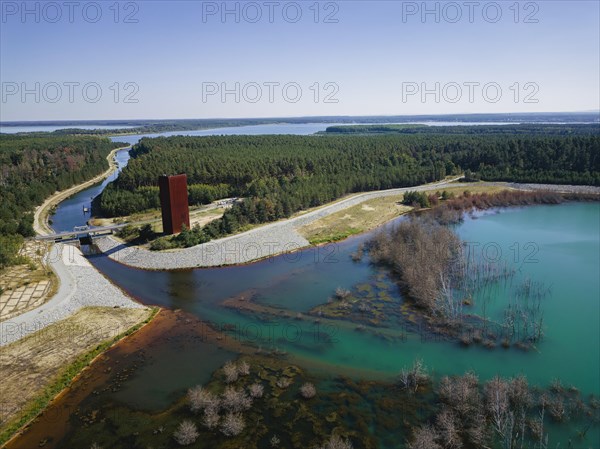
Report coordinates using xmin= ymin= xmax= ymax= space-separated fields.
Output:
xmin=0 ymin=307 xmax=151 ymax=448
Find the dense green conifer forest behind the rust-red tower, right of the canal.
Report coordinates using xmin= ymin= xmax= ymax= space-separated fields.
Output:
xmin=96 ymin=125 xmax=600 ymax=246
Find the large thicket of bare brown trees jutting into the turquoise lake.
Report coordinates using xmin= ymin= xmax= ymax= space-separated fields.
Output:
xmin=369 ymin=218 xmax=550 ymax=347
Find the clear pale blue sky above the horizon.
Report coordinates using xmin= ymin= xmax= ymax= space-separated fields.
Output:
xmin=0 ymin=0 xmax=600 ymax=121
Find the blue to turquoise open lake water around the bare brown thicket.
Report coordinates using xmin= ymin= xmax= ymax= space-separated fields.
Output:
xmin=91 ymin=203 xmax=600 ymax=395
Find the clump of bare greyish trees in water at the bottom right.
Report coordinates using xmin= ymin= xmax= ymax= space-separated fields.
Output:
xmin=408 ymin=373 xmax=588 ymax=449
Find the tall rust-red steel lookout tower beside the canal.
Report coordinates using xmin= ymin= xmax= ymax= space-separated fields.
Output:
xmin=158 ymin=175 xmax=190 ymax=234
